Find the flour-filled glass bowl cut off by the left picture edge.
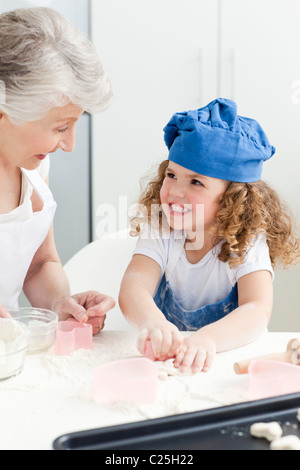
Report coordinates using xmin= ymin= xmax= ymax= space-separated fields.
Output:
xmin=0 ymin=318 xmax=30 ymax=380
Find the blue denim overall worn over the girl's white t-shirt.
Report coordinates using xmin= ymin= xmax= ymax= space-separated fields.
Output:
xmin=154 ymin=238 xmax=238 ymax=331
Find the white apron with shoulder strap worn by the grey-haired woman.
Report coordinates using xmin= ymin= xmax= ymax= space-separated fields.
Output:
xmin=0 ymin=168 xmax=56 ymax=309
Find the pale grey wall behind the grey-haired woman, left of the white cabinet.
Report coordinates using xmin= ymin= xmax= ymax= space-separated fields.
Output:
xmin=0 ymin=0 xmax=91 ymax=264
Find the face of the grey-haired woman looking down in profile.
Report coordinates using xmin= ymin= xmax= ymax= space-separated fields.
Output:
xmin=0 ymin=103 xmax=83 ymax=170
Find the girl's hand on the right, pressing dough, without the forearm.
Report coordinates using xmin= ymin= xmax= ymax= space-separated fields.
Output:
xmin=174 ymin=332 xmax=216 ymax=374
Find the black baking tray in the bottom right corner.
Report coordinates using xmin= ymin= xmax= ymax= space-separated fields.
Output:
xmin=53 ymin=393 xmax=300 ymax=451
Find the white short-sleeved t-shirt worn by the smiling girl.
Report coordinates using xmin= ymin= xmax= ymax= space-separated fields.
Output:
xmin=133 ymin=228 xmax=274 ymax=310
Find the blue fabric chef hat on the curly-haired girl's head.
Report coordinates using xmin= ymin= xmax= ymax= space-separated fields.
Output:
xmin=164 ymin=98 xmax=275 ymax=183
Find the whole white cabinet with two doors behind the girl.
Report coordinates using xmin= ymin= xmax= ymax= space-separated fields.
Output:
xmin=92 ymin=0 xmax=300 ymax=331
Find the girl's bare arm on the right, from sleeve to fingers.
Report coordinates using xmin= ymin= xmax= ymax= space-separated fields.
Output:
xmin=174 ymin=271 xmax=273 ymax=372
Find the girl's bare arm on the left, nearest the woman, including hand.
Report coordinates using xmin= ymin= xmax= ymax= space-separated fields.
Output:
xmin=119 ymin=255 xmax=182 ymax=359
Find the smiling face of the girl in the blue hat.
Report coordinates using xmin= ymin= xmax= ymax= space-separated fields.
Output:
xmin=160 ymin=162 xmax=227 ymax=241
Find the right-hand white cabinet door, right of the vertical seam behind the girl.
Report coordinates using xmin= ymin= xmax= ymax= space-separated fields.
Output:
xmin=219 ymin=0 xmax=300 ymax=331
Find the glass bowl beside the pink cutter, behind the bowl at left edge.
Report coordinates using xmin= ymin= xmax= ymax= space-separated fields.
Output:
xmin=8 ymin=307 xmax=58 ymax=354
